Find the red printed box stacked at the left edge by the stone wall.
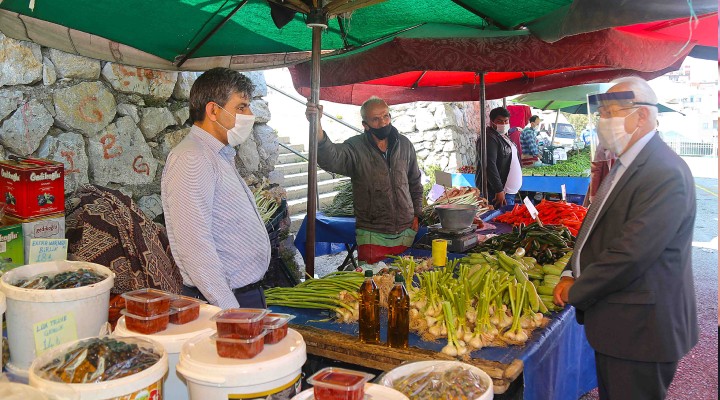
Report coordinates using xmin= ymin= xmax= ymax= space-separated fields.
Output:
xmin=0 ymin=159 xmax=65 ymax=219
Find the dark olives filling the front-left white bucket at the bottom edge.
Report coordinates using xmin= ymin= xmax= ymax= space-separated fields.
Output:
xmin=40 ymin=337 xmax=161 ymax=383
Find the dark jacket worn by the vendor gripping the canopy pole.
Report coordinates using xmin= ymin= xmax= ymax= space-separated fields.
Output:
xmin=318 ymin=128 xmax=423 ymax=234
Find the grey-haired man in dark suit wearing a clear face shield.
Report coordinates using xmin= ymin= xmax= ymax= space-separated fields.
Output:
xmin=554 ymin=78 xmax=698 ymax=400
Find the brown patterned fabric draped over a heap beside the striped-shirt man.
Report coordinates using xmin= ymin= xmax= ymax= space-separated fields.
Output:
xmin=65 ymin=185 xmax=182 ymax=293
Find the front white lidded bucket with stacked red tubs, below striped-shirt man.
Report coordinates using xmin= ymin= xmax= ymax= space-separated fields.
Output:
xmin=177 ymin=329 xmax=307 ymax=400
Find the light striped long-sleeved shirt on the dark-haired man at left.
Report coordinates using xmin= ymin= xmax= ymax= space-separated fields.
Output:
xmin=162 ymin=126 xmax=270 ymax=308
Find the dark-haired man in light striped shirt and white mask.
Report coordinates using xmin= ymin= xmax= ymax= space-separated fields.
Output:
xmin=162 ymin=68 xmax=270 ymax=308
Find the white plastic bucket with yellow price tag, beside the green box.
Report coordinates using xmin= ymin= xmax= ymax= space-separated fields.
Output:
xmin=0 ymin=261 xmax=115 ymax=375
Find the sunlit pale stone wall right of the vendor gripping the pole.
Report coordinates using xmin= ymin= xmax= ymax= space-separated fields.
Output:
xmin=390 ymin=101 xmax=502 ymax=172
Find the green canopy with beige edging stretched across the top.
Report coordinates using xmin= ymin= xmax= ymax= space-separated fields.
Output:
xmin=0 ymin=0 xmax=717 ymax=70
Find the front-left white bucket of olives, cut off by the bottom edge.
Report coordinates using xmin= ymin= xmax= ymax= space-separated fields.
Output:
xmin=30 ymin=338 xmax=170 ymax=400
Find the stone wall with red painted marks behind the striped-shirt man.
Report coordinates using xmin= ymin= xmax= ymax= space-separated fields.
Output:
xmin=0 ymin=33 xmax=278 ymax=222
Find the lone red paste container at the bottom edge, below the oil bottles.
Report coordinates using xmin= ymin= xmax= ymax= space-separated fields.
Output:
xmin=308 ymin=367 xmax=374 ymax=400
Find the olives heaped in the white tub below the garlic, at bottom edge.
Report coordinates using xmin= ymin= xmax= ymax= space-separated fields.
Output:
xmin=383 ymin=362 xmax=488 ymax=400
